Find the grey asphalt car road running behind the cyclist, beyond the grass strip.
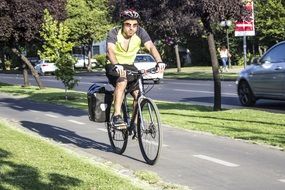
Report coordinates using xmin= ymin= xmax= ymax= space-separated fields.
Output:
xmin=0 ymin=73 xmax=285 ymax=113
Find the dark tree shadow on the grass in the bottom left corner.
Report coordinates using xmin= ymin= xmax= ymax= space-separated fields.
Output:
xmin=0 ymin=149 xmax=82 ymax=190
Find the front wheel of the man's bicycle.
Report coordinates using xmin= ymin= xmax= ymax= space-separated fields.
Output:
xmin=138 ymin=99 xmax=162 ymax=165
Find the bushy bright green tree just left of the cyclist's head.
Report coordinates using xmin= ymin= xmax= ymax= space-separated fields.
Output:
xmin=67 ymin=0 xmax=112 ymax=70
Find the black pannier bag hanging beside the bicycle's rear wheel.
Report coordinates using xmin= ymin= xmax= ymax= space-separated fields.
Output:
xmin=87 ymin=84 xmax=113 ymax=122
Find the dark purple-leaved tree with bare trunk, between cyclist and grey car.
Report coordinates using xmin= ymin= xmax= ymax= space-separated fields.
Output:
xmin=110 ymin=0 xmax=243 ymax=110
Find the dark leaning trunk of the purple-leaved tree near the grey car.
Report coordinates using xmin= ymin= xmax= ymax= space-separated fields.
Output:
xmin=208 ymin=33 xmax=222 ymax=111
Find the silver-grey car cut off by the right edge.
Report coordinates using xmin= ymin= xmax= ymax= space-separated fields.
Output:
xmin=237 ymin=41 xmax=285 ymax=106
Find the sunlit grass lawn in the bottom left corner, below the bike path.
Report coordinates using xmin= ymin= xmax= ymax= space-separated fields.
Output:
xmin=0 ymin=120 xmax=139 ymax=190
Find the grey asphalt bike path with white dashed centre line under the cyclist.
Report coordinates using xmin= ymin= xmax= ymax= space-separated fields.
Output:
xmin=0 ymin=93 xmax=285 ymax=190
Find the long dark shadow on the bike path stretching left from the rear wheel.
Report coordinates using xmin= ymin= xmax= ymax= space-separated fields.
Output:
xmin=21 ymin=121 xmax=112 ymax=152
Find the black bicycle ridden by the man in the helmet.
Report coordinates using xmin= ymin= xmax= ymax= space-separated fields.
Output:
xmin=106 ymin=68 xmax=162 ymax=165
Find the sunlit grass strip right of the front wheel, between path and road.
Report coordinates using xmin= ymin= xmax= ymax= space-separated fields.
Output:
xmin=157 ymin=101 xmax=285 ymax=149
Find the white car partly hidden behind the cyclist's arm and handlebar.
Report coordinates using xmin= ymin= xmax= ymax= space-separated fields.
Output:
xmin=134 ymin=54 xmax=163 ymax=83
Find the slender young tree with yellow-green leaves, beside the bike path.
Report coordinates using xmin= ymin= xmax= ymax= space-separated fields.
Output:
xmin=39 ymin=9 xmax=78 ymax=99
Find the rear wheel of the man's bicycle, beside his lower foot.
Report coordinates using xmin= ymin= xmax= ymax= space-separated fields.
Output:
xmin=107 ymin=105 xmax=128 ymax=154
